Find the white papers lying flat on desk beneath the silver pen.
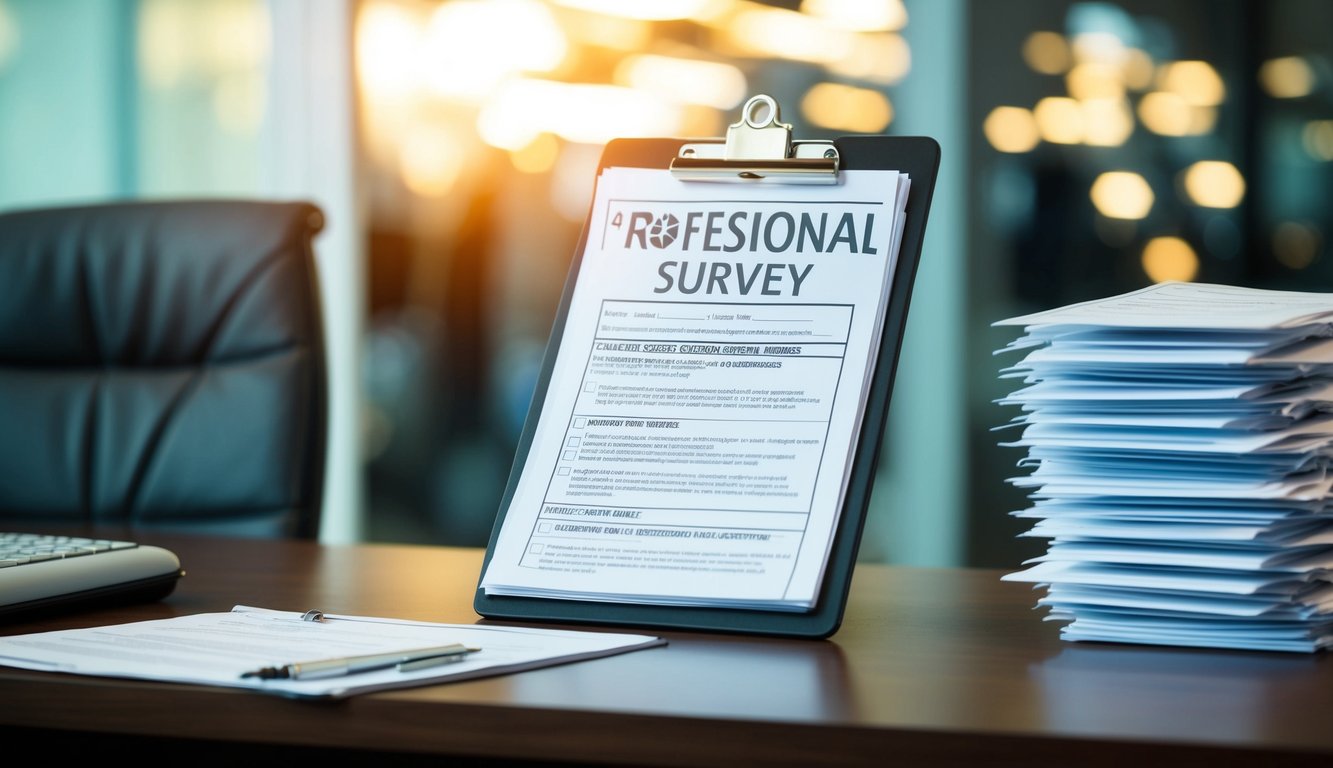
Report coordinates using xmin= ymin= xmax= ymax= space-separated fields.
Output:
xmin=0 ymin=605 xmax=667 ymax=699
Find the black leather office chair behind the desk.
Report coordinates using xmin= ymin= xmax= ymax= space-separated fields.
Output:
xmin=0 ymin=200 xmax=328 ymax=539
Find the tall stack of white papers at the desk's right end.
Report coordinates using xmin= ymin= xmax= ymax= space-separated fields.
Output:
xmin=996 ymin=283 xmax=1333 ymax=652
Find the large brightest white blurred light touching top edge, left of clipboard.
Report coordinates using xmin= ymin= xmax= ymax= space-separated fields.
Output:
xmin=419 ymin=0 xmax=568 ymax=99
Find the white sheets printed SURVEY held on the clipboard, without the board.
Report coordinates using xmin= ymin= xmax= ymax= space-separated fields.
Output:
xmin=481 ymin=168 xmax=909 ymax=611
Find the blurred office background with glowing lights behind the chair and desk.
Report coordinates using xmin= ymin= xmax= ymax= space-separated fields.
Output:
xmin=0 ymin=0 xmax=1333 ymax=568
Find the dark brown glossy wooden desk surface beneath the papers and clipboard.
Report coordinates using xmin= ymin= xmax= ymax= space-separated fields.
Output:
xmin=0 ymin=529 xmax=1333 ymax=768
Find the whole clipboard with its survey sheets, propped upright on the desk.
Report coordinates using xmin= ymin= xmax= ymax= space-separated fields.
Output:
xmin=473 ymin=96 xmax=940 ymax=637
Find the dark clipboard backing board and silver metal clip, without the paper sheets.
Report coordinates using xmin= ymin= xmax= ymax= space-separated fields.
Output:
xmin=473 ymin=95 xmax=940 ymax=639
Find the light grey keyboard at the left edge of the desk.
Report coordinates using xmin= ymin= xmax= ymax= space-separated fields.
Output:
xmin=0 ymin=532 xmax=185 ymax=620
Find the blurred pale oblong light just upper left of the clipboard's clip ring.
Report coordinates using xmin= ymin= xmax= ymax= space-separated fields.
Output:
xmin=615 ymin=53 xmax=748 ymax=109
